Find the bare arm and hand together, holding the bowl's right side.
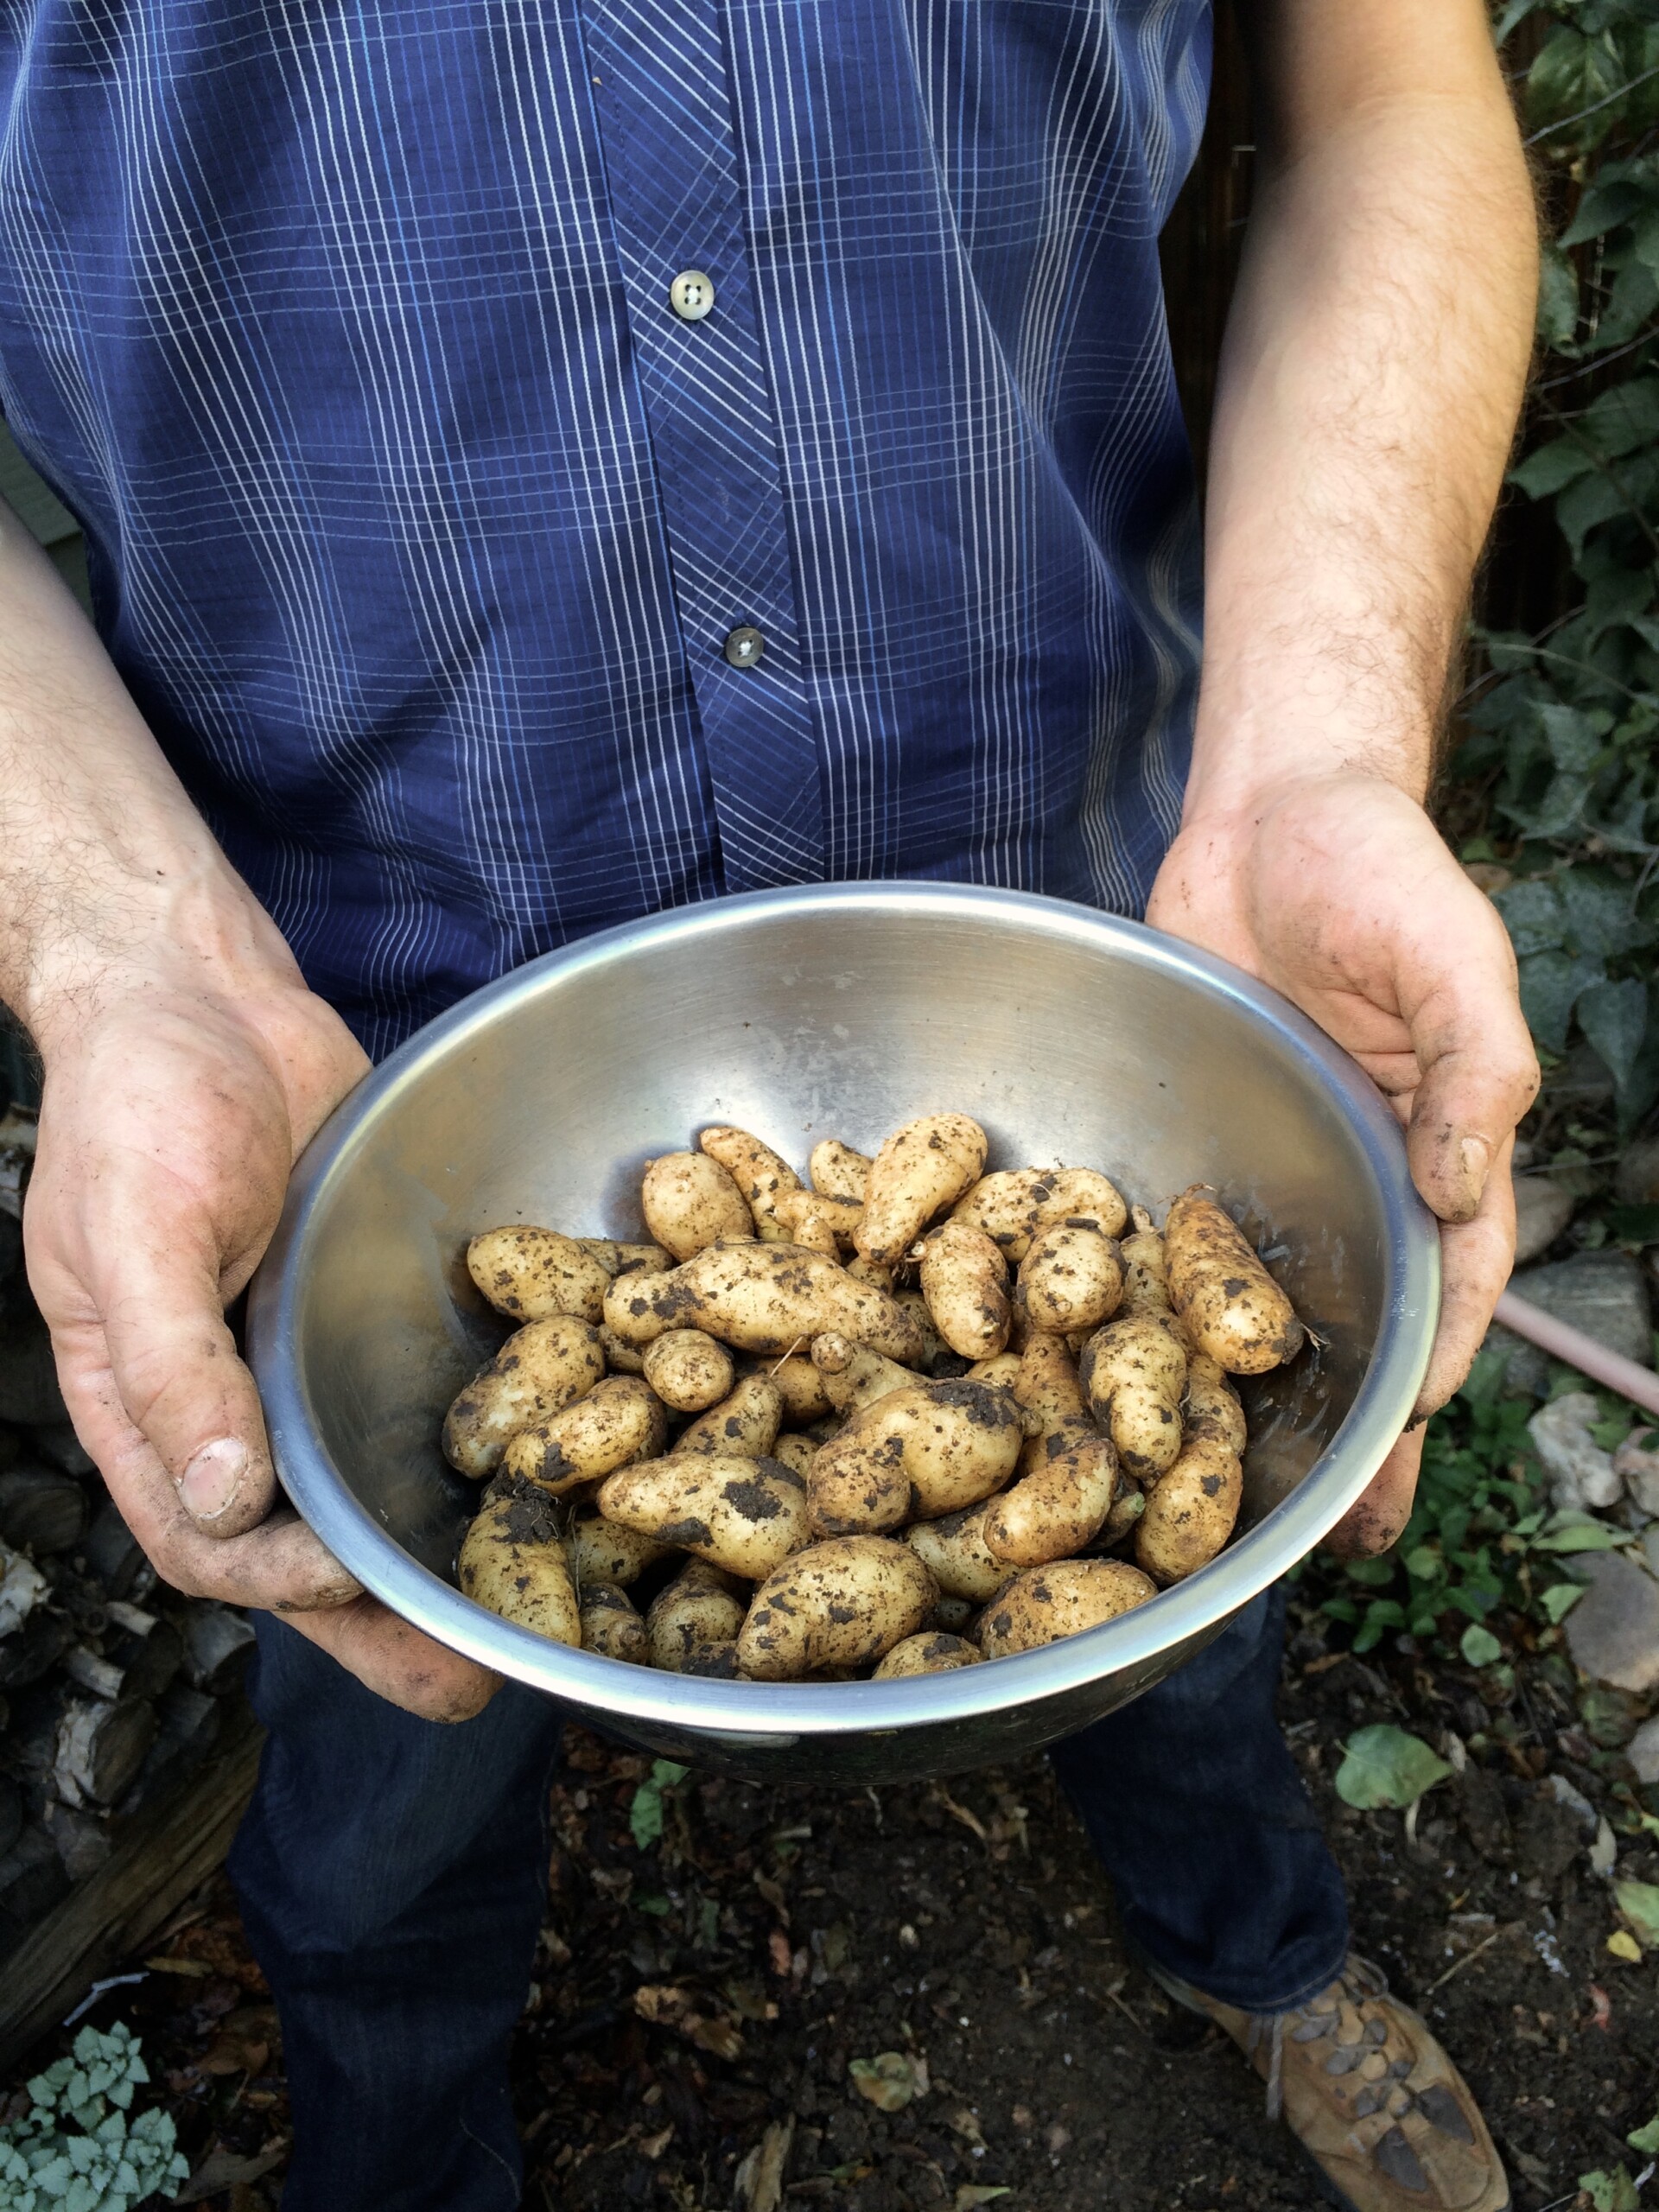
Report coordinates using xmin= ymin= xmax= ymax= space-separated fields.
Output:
xmin=1150 ymin=0 xmax=1537 ymax=1553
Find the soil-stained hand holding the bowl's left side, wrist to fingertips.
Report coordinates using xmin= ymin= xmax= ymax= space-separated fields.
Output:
xmin=24 ymin=964 xmax=495 ymax=1721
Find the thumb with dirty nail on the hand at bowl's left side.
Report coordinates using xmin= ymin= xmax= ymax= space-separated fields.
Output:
xmin=99 ymin=1217 xmax=276 ymax=1535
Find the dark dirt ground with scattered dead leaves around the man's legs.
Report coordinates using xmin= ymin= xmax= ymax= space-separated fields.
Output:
xmin=16 ymin=1626 xmax=1659 ymax=2212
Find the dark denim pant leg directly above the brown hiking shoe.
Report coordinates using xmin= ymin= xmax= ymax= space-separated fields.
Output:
xmin=1051 ymin=1586 xmax=1347 ymax=2013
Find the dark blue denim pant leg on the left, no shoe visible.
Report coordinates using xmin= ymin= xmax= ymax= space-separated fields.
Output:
xmin=230 ymin=1615 xmax=560 ymax=2212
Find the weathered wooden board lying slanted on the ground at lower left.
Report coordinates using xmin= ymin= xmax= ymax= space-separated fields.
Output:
xmin=0 ymin=1703 xmax=265 ymax=2066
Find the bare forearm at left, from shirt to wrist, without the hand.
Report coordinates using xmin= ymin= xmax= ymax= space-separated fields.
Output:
xmin=0 ymin=505 xmax=301 ymax=1058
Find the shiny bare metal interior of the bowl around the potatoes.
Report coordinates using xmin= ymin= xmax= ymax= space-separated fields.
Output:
xmin=281 ymin=887 xmax=1427 ymax=1580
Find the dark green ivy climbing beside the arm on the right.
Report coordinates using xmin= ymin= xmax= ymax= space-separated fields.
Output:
xmin=1451 ymin=0 xmax=1659 ymax=1132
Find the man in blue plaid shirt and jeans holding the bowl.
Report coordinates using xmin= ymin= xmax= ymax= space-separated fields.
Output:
xmin=0 ymin=0 xmax=1535 ymax=2212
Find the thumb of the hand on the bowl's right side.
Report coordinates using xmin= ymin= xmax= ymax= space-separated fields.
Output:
xmin=1405 ymin=885 xmax=1540 ymax=1221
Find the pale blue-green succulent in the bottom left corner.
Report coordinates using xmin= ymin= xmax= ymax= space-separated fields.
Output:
xmin=0 ymin=2019 xmax=190 ymax=2212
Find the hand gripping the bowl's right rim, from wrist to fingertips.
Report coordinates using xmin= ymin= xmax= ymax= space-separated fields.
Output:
xmin=1146 ymin=772 xmax=1537 ymax=1553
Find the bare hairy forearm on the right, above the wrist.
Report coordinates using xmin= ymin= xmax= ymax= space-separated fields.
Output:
xmin=1188 ymin=0 xmax=1537 ymax=821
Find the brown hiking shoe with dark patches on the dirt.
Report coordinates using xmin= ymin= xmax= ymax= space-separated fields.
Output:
xmin=1148 ymin=1953 xmax=1509 ymax=2212
